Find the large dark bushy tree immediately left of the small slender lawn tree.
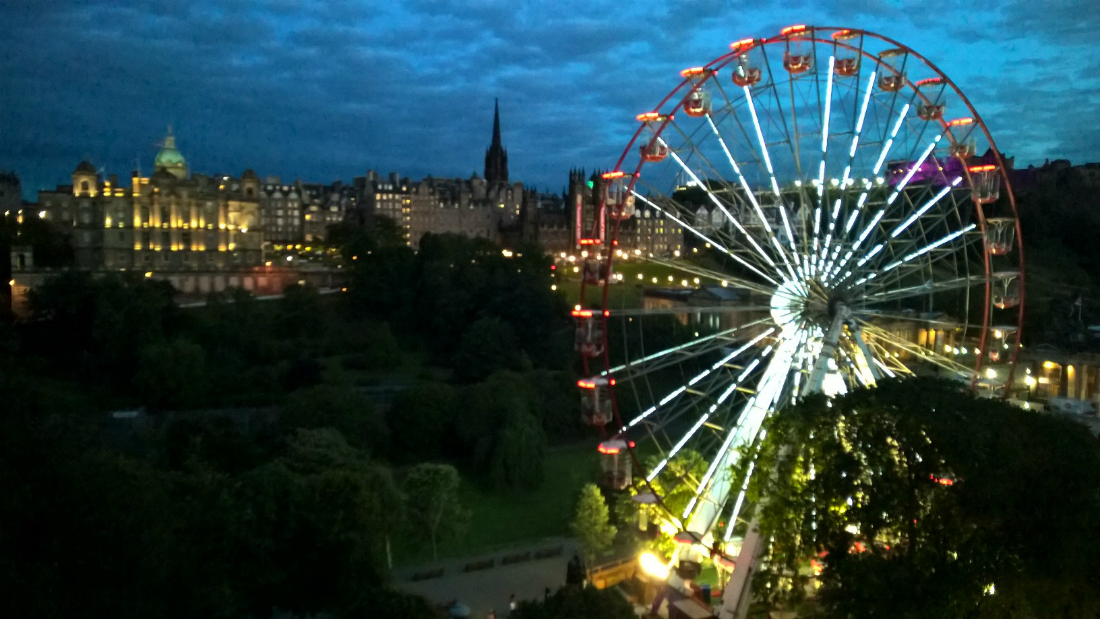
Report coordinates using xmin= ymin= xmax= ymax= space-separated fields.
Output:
xmin=239 ymin=429 xmax=402 ymax=616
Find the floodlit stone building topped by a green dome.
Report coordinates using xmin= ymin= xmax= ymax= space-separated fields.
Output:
xmin=39 ymin=129 xmax=263 ymax=272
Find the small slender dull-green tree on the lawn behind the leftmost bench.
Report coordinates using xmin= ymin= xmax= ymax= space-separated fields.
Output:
xmin=402 ymin=463 xmax=470 ymax=560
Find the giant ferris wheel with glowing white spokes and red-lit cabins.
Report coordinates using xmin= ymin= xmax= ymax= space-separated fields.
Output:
xmin=573 ymin=25 xmax=1024 ymax=571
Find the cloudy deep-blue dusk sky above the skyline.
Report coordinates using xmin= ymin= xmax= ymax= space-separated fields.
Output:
xmin=0 ymin=0 xmax=1100 ymax=197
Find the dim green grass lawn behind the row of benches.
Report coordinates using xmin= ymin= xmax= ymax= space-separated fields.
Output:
xmin=394 ymin=439 xmax=600 ymax=565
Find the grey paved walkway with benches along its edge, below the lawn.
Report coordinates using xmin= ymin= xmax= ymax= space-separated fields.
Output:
xmin=394 ymin=538 xmax=580 ymax=619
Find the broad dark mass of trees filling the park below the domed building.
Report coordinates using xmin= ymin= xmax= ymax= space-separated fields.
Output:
xmin=0 ymin=225 xmax=580 ymax=618
